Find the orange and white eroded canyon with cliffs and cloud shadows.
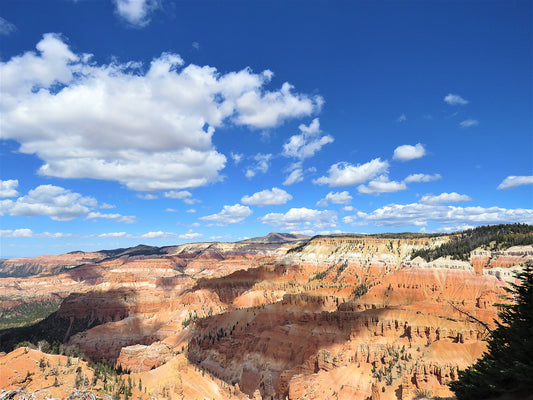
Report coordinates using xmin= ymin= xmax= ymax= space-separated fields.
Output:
xmin=0 ymin=230 xmax=533 ymax=400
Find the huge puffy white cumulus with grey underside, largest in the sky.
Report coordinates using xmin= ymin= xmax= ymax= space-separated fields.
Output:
xmin=0 ymin=33 xmax=322 ymax=192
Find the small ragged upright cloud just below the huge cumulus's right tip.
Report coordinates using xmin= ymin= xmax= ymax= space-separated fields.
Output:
xmin=282 ymin=118 xmax=333 ymax=160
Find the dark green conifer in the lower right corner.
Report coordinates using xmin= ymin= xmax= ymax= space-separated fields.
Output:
xmin=450 ymin=263 xmax=533 ymax=400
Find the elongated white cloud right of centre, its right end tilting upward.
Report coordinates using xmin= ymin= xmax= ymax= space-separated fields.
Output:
xmin=313 ymin=158 xmax=389 ymax=187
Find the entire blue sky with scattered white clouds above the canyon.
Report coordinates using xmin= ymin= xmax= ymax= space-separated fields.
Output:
xmin=0 ymin=0 xmax=533 ymax=257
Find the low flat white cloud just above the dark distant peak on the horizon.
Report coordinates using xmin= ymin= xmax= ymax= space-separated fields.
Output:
xmin=259 ymin=207 xmax=337 ymax=231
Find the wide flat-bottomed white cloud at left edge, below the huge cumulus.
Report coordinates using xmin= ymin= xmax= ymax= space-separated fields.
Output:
xmin=0 ymin=185 xmax=98 ymax=221
